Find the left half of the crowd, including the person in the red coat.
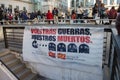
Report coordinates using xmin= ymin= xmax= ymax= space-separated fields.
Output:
xmin=0 ymin=7 xmax=65 ymax=24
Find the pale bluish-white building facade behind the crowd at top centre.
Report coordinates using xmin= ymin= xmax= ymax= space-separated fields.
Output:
xmin=35 ymin=0 xmax=68 ymax=12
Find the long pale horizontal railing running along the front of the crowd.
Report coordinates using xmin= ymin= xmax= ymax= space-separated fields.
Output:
xmin=0 ymin=18 xmax=115 ymax=25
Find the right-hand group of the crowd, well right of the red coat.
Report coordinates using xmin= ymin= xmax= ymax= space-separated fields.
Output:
xmin=72 ymin=3 xmax=120 ymax=24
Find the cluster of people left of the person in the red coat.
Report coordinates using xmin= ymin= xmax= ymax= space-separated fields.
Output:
xmin=0 ymin=7 xmax=45 ymax=24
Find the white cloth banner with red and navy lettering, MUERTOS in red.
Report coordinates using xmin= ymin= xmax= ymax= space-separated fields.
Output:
xmin=23 ymin=26 xmax=104 ymax=66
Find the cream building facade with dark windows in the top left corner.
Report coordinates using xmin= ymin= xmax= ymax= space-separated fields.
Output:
xmin=0 ymin=0 xmax=34 ymax=13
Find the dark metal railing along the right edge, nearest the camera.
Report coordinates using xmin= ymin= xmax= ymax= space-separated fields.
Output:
xmin=108 ymin=30 xmax=120 ymax=80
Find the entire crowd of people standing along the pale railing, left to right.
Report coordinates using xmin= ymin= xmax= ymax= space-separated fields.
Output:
xmin=0 ymin=3 xmax=120 ymax=24
